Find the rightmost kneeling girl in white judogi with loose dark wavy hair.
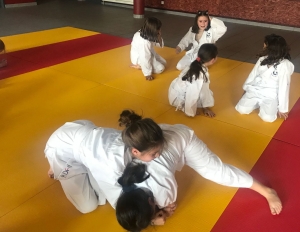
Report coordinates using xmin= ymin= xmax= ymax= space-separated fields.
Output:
xmin=235 ymin=34 xmax=294 ymax=122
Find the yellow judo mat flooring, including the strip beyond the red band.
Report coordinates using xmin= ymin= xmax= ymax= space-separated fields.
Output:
xmin=0 ymin=27 xmax=300 ymax=232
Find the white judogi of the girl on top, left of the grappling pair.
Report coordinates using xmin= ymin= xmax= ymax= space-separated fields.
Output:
xmin=45 ymin=120 xmax=132 ymax=213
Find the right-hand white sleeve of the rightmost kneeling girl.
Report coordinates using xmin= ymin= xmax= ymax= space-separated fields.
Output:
xmin=278 ymin=60 xmax=294 ymax=113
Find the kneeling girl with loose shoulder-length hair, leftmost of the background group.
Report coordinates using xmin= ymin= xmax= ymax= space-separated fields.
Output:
xmin=130 ymin=17 xmax=166 ymax=81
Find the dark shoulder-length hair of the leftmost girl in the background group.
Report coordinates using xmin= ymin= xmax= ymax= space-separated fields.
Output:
xmin=140 ymin=17 xmax=162 ymax=43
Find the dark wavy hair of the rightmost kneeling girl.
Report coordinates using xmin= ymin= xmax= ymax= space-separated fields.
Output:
xmin=257 ymin=34 xmax=291 ymax=65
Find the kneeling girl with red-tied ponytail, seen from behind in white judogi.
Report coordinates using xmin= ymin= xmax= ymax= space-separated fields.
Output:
xmin=169 ymin=44 xmax=218 ymax=117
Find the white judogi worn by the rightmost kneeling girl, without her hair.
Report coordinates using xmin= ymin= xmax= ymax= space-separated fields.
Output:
xmin=235 ymin=57 xmax=294 ymax=122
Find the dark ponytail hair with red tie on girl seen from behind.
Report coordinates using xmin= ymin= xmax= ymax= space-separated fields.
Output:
xmin=182 ymin=44 xmax=218 ymax=83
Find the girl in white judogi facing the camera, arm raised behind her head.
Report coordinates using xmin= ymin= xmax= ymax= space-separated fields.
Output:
xmin=175 ymin=10 xmax=227 ymax=70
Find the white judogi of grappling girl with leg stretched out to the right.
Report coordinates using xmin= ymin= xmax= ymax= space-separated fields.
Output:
xmin=138 ymin=124 xmax=253 ymax=208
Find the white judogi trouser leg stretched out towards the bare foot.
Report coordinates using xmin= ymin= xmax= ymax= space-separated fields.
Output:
xmin=185 ymin=132 xmax=253 ymax=188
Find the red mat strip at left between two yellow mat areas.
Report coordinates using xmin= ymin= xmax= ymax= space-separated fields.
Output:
xmin=0 ymin=34 xmax=131 ymax=80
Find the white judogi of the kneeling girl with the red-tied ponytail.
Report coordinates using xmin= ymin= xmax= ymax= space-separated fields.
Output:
xmin=169 ymin=66 xmax=214 ymax=117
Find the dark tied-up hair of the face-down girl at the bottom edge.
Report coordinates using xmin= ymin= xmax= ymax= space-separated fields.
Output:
xmin=116 ymin=163 xmax=155 ymax=232
